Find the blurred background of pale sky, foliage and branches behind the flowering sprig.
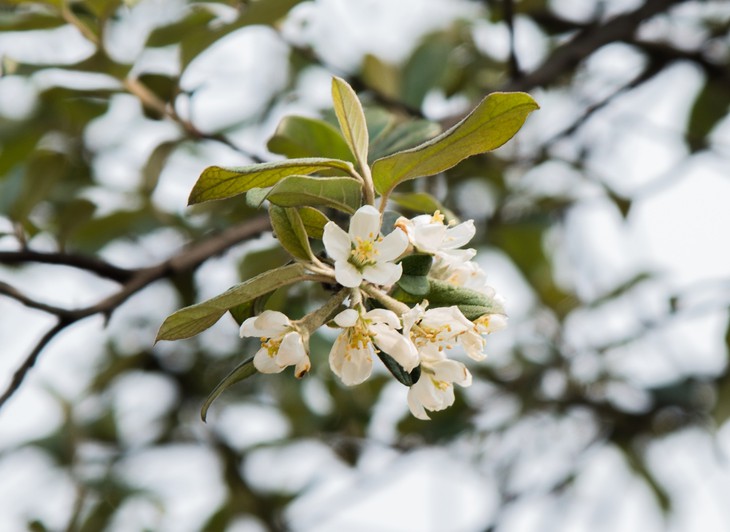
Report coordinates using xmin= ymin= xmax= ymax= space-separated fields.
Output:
xmin=0 ymin=0 xmax=730 ymax=532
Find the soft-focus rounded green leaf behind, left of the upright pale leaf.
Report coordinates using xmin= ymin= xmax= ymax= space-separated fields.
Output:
xmin=266 ymin=116 xmax=355 ymax=163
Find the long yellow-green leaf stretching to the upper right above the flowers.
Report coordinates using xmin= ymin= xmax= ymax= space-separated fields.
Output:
xmin=373 ymin=92 xmax=538 ymax=194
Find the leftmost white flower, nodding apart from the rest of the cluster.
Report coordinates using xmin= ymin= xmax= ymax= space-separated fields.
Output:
xmin=241 ymin=310 xmax=311 ymax=378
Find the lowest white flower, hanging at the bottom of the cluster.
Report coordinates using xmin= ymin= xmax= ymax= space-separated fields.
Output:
xmin=408 ymin=353 xmax=471 ymax=419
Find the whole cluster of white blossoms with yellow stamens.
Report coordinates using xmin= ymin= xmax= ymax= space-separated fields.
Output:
xmin=241 ymin=205 xmax=507 ymax=419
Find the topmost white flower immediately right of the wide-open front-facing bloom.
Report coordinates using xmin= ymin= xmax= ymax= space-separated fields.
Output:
xmin=395 ymin=211 xmax=476 ymax=260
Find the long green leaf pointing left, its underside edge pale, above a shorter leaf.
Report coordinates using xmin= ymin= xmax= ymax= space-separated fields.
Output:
xmin=188 ymin=158 xmax=352 ymax=205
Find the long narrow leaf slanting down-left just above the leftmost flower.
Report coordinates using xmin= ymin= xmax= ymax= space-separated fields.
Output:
xmin=155 ymin=264 xmax=308 ymax=342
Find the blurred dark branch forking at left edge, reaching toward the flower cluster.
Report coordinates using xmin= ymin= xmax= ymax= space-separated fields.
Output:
xmin=0 ymin=216 xmax=269 ymax=408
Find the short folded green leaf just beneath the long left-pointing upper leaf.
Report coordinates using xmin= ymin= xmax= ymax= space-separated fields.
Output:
xmin=266 ymin=175 xmax=362 ymax=214
